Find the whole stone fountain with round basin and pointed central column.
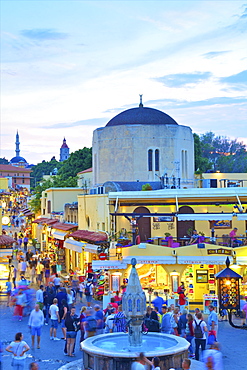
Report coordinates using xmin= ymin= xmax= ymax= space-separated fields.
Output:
xmin=81 ymin=258 xmax=189 ymax=370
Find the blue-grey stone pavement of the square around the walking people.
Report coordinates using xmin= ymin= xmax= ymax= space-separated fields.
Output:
xmin=0 ymin=294 xmax=247 ymax=370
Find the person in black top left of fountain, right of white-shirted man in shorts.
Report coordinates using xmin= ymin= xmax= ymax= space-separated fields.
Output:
xmin=65 ymin=307 xmax=80 ymax=357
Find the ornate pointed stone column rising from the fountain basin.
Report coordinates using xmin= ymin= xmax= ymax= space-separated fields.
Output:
xmin=122 ymin=258 xmax=146 ymax=348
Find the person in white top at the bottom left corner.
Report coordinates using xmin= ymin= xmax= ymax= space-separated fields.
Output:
xmin=6 ymin=333 xmax=30 ymax=370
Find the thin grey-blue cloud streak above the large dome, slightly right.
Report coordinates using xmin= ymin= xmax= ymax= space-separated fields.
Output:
xmin=155 ymin=72 xmax=212 ymax=87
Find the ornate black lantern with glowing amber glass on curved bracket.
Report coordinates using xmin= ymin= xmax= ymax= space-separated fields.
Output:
xmin=215 ymin=257 xmax=247 ymax=329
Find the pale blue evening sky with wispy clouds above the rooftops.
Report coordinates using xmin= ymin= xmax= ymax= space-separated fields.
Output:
xmin=0 ymin=0 xmax=247 ymax=164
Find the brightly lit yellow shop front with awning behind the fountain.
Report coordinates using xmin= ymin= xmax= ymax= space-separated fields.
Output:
xmin=104 ymin=243 xmax=247 ymax=312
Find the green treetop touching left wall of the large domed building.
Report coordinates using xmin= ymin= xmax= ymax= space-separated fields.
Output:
xmin=58 ymin=147 xmax=92 ymax=179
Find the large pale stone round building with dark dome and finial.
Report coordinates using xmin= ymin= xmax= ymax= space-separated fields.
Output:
xmin=93 ymin=97 xmax=194 ymax=188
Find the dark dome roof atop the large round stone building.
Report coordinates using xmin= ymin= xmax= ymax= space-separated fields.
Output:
xmin=106 ymin=105 xmax=178 ymax=126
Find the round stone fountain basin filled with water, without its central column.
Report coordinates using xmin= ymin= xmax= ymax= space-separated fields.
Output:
xmin=81 ymin=333 xmax=190 ymax=370
